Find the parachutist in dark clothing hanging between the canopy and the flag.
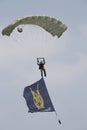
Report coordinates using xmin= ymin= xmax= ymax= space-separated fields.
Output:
xmin=37 ymin=58 xmax=46 ymax=77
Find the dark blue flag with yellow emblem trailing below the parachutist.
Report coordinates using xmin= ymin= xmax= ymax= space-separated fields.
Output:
xmin=23 ymin=78 xmax=55 ymax=112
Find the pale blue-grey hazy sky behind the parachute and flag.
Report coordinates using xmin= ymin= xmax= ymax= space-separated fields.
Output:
xmin=0 ymin=0 xmax=87 ymax=130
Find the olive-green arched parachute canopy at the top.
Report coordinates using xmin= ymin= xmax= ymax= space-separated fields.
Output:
xmin=2 ymin=16 xmax=67 ymax=37
